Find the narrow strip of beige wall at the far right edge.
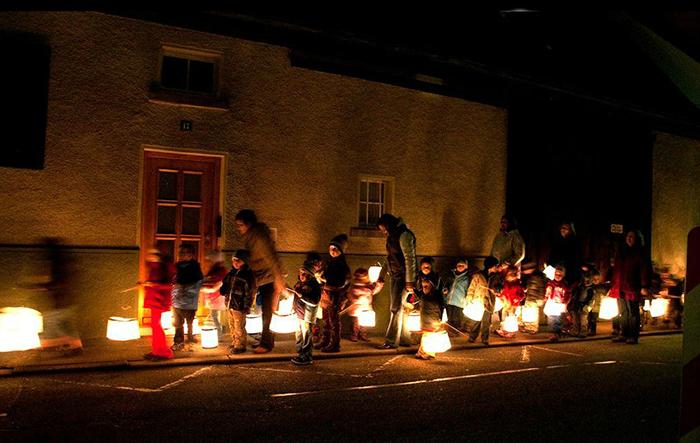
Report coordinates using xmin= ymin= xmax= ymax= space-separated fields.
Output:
xmin=651 ymin=133 xmax=700 ymax=276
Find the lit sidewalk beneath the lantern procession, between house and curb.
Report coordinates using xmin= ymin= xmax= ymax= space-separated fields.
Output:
xmin=0 ymin=322 xmax=682 ymax=377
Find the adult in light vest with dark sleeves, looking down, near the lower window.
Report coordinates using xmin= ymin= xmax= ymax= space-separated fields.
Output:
xmin=377 ymin=214 xmax=416 ymax=349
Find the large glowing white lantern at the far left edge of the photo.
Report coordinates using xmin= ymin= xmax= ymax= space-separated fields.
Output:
xmin=0 ymin=308 xmax=43 ymax=352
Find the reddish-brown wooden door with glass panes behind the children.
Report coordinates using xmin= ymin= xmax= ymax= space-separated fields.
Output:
xmin=139 ymin=151 xmax=221 ymax=324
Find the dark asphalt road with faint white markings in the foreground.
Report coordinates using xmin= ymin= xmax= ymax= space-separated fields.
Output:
xmin=0 ymin=335 xmax=682 ymax=443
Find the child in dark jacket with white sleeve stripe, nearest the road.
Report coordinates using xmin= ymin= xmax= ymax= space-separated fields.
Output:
xmin=291 ymin=261 xmax=321 ymax=366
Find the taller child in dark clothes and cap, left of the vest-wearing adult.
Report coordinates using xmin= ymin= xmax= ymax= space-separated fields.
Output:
xmin=316 ymin=234 xmax=350 ymax=352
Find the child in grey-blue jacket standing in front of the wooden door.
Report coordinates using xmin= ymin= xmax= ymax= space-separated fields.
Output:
xmin=170 ymin=244 xmax=204 ymax=351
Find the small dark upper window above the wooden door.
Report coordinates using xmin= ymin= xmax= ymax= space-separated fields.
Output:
xmin=160 ymin=48 xmax=218 ymax=95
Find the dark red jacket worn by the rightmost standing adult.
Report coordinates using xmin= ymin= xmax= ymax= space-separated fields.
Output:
xmin=610 ymin=244 xmax=651 ymax=302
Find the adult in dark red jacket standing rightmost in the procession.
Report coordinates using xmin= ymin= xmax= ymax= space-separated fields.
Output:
xmin=610 ymin=230 xmax=651 ymax=344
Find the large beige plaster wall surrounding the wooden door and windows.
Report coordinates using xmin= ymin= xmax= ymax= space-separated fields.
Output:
xmin=0 ymin=12 xmax=506 ymax=336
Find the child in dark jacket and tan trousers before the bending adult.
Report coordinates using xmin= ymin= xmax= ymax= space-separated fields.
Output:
xmin=219 ymin=249 xmax=255 ymax=354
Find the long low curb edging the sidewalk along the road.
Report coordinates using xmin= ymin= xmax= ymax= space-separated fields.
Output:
xmin=0 ymin=330 xmax=683 ymax=378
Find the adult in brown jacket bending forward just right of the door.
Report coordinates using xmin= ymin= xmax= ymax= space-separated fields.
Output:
xmin=236 ymin=209 xmax=285 ymax=354
